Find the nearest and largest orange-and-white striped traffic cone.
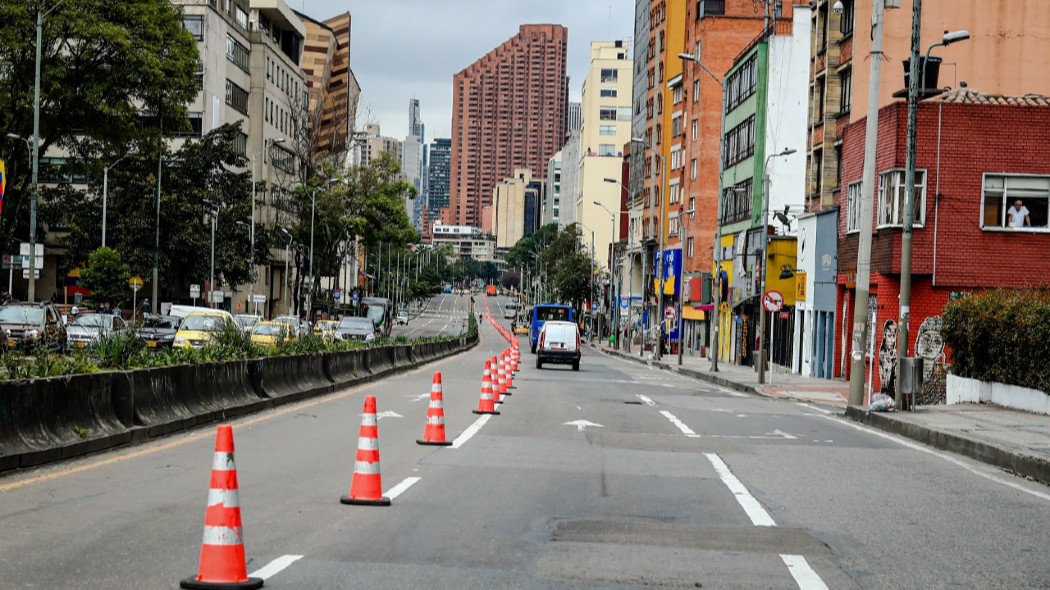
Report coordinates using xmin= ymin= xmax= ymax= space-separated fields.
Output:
xmin=179 ymin=424 xmax=263 ymax=590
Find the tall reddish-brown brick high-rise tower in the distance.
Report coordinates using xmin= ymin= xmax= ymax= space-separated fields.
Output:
xmin=442 ymin=24 xmax=569 ymax=228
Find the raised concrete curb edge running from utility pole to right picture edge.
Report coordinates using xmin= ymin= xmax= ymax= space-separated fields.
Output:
xmin=846 ymin=405 xmax=1050 ymax=483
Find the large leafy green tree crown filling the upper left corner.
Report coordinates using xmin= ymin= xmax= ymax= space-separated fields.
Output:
xmin=0 ymin=0 xmax=198 ymax=249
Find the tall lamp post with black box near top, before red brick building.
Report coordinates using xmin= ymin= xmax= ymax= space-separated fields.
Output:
xmin=894 ymin=28 xmax=970 ymax=407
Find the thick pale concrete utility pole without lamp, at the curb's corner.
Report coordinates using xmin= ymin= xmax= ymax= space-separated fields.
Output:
xmin=849 ymin=0 xmax=885 ymax=405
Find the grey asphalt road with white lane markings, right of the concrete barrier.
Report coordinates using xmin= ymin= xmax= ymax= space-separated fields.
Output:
xmin=0 ymin=296 xmax=1050 ymax=589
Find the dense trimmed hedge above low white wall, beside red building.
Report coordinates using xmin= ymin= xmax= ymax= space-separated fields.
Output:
xmin=941 ymin=289 xmax=1050 ymax=394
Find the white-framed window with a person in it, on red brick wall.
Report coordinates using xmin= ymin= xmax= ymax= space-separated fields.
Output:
xmin=981 ymin=174 xmax=1050 ymax=230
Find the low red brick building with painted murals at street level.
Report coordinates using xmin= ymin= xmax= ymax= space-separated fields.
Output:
xmin=835 ymin=88 xmax=1050 ymax=392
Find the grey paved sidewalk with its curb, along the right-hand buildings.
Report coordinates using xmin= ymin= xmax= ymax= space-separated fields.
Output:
xmin=589 ymin=342 xmax=1050 ymax=483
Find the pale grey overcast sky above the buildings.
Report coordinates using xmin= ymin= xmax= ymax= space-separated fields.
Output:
xmin=300 ymin=0 xmax=634 ymax=143
